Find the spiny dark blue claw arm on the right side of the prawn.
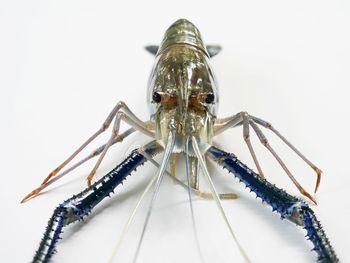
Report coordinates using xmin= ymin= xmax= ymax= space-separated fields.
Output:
xmin=207 ymin=146 xmax=339 ymax=263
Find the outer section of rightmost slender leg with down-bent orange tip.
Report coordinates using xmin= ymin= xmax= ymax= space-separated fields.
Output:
xmin=250 ymin=116 xmax=322 ymax=193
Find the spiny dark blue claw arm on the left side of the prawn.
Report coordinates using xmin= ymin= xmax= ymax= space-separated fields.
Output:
xmin=32 ymin=141 xmax=163 ymax=263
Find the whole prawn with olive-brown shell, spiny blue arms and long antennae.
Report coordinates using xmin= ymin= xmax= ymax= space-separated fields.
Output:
xmin=21 ymin=19 xmax=339 ymax=263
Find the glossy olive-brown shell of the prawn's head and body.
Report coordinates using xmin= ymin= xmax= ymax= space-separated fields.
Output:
xmin=147 ymin=19 xmax=219 ymax=151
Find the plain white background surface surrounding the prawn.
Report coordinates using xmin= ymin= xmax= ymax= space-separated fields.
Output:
xmin=0 ymin=0 xmax=350 ymax=262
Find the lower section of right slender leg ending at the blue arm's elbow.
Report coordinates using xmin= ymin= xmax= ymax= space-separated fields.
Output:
xmin=250 ymin=121 xmax=317 ymax=204
